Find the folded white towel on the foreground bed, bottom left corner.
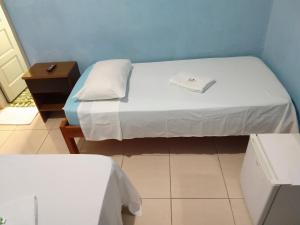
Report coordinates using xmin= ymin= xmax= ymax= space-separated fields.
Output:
xmin=0 ymin=195 xmax=37 ymax=225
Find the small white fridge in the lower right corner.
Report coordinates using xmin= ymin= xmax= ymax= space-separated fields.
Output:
xmin=241 ymin=134 xmax=300 ymax=225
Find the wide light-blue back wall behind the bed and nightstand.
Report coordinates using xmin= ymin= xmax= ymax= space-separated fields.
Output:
xmin=4 ymin=0 xmax=272 ymax=69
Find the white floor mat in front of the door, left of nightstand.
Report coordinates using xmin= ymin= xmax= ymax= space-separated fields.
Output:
xmin=0 ymin=107 xmax=38 ymax=125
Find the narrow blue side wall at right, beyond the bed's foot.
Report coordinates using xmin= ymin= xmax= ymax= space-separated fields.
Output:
xmin=262 ymin=0 xmax=300 ymax=118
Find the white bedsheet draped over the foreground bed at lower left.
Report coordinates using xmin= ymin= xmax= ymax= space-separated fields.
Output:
xmin=0 ymin=155 xmax=141 ymax=225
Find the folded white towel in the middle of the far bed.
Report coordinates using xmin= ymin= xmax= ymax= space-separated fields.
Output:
xmin=170 ymin=72 xmax=216 ymax=93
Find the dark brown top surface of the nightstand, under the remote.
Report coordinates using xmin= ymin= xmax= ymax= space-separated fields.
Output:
xmin=22 ymin=61 xmax=77 ymax=80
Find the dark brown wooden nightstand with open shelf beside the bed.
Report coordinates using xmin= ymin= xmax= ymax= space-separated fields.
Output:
xmin=22 ymin=61 xmax=80 ymax=122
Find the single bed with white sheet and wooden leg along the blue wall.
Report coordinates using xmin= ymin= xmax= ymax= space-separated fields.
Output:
xmin=61 ymin=57 xmax=298 ymax=153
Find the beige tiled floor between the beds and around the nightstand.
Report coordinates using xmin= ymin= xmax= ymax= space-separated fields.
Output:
xmin=0 ymin=116 xmax=251 ymax=225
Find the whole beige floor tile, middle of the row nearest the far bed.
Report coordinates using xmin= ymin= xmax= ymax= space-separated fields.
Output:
xmin=170 ymin=154 xmax=227 ymax=198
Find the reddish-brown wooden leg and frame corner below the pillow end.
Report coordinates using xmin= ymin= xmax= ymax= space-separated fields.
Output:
xmin=60 ymin=118 xmax=84 ymax=154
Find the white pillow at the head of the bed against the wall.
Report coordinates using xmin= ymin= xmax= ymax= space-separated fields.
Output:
xmin=75 ymin=59 xmax=132 ymax=101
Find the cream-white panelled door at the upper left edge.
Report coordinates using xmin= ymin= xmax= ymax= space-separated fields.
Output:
xmin=0 ymin=4 xmax=27 ymax=102
